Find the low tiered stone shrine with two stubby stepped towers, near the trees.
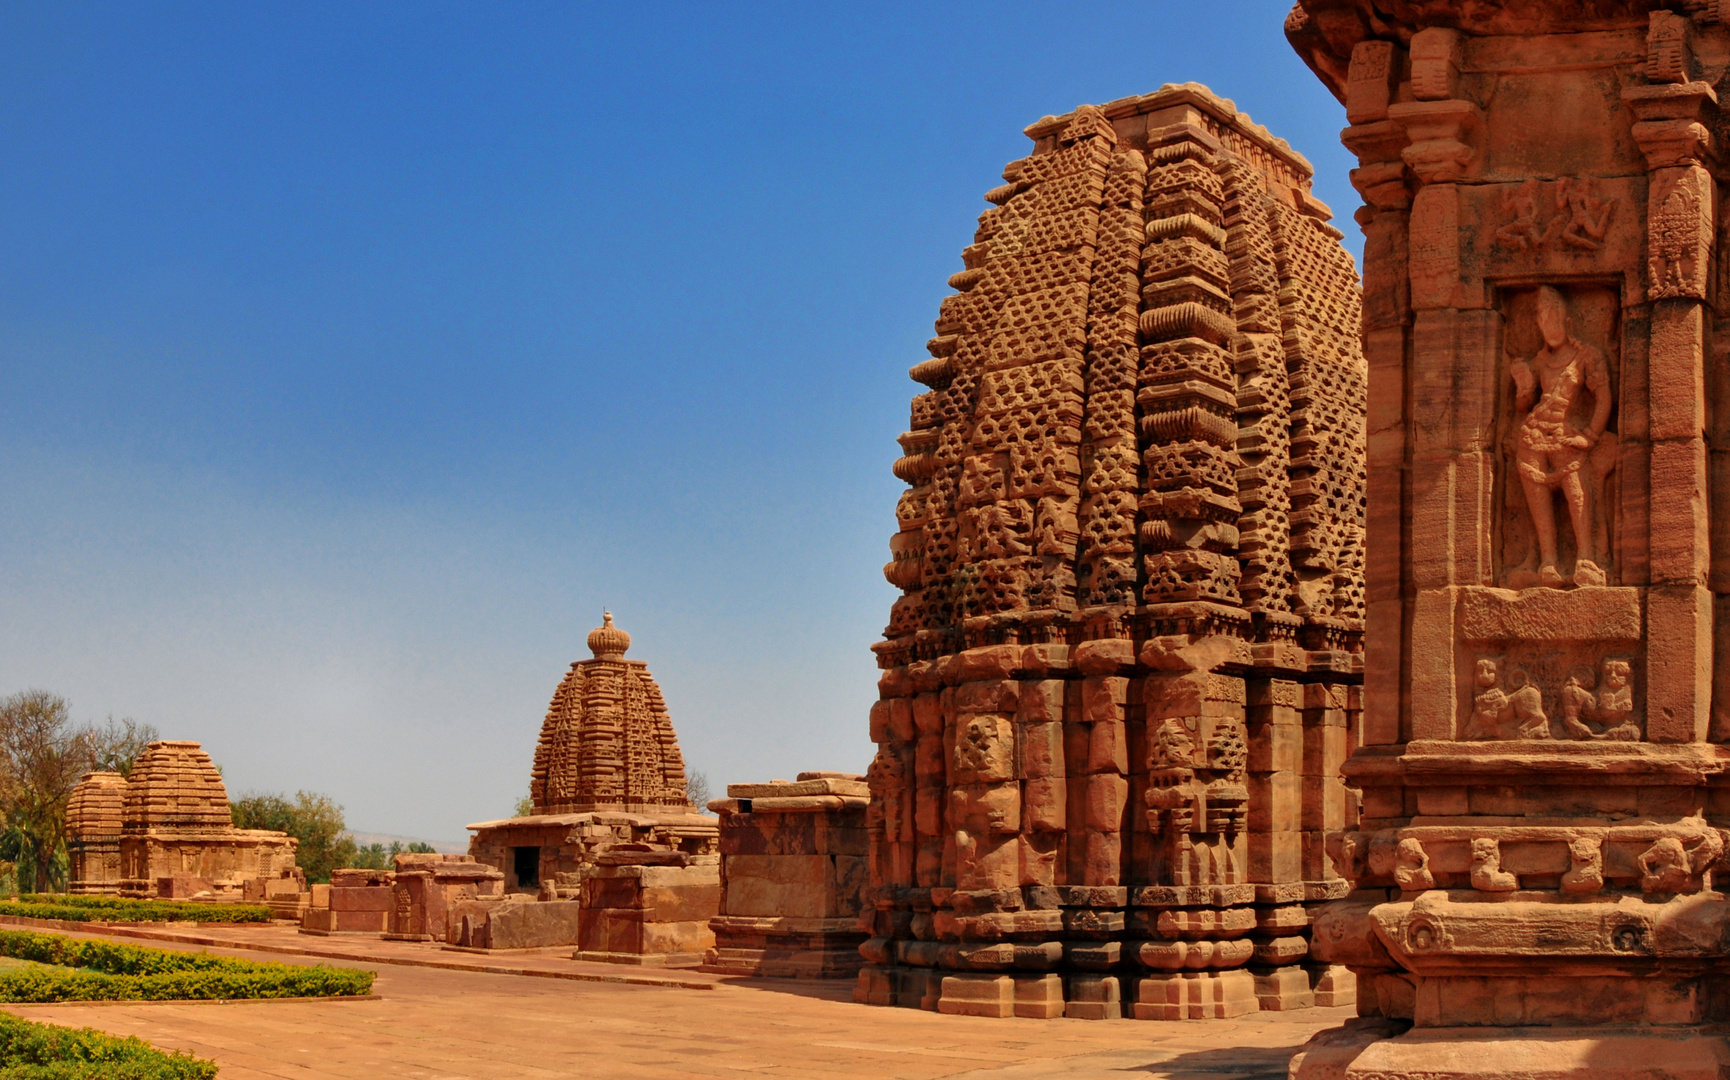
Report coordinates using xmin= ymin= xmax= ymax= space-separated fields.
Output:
xmin=66 ymin=741 xmax=304 ymax=909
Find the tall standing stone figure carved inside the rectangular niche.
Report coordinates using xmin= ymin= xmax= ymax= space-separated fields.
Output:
xmin=1510 ymin=286 xmax=1611 ymax=588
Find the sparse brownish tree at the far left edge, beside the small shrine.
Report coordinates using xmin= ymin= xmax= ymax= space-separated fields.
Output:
xmin=0 ymin=691 xmax=93 ymax=891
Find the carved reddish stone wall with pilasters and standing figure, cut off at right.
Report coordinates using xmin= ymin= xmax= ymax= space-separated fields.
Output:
xmin=1287 ymin=0 xmax=1730 ymax=1078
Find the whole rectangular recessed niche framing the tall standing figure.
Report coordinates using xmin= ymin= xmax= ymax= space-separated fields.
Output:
xmin=1496 ymin=282 xmax=1621 ymax=588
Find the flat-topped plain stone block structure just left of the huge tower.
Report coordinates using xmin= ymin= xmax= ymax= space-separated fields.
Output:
xmin=702 ymin=772 xmax=870 ymax=978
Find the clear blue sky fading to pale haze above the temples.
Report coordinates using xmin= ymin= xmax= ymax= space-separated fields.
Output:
xmin=0 ymin=0 xmax=1358 ymax=839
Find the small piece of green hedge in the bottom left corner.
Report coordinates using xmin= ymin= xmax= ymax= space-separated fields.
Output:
xmin=0 ymin=1013 xmax=216 ymax=1080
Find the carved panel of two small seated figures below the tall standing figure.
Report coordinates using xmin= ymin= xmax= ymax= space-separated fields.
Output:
xmin=1460 ymin=658 xmax=1640 ymax=743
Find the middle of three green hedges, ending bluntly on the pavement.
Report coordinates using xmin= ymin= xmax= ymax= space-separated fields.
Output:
xmin=0 ymin=931 xmax=374 ymax=1003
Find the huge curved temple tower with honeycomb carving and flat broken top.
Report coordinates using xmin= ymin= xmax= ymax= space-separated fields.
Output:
xmin=856 ymin=85 xmax=1365 ymax=1019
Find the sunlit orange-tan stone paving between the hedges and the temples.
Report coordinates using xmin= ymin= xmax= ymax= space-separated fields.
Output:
xmin=5 ymin=928 xmax=1351 ymax=1080
